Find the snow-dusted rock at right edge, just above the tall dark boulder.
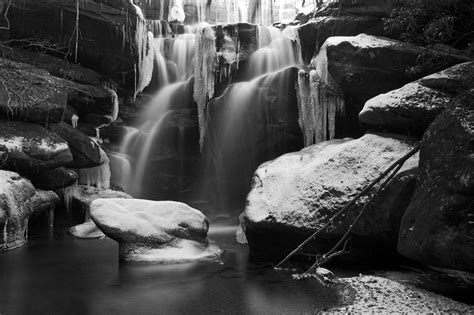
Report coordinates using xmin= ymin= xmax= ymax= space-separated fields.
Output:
xmin=359 ymin=62 xmax=474 ymax=133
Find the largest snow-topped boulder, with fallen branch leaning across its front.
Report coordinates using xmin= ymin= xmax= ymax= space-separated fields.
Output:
xmin=241 ymin=134 xmax=418 ymax=259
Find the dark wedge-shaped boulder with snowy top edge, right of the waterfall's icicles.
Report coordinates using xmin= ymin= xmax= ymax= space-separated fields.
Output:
xmin=311 ymin=34 xmax=468 ymax=138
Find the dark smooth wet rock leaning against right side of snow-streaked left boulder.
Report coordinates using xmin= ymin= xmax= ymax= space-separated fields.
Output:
xmin=49 ymin=122 xmax=104 ymax=168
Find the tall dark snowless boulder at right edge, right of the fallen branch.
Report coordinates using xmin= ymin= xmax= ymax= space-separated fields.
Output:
xmin=398 ymin=90 xmax=474 ymax=272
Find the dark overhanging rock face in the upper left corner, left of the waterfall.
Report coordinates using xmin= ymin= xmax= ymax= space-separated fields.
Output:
xmin=8 ymin=0 xmax=146 ymax=90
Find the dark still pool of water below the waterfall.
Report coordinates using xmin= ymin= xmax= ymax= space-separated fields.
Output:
xmin=0 ymin=221 xmax=339 ymax=314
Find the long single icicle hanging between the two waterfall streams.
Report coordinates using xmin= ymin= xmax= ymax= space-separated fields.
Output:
xmin=194 ymin=23 xmax=217 ymax=149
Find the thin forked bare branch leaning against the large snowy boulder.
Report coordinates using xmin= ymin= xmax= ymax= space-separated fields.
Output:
xmin=276 ymin=143 xmax=420 ymax=270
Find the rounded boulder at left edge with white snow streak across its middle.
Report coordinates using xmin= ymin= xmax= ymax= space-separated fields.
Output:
xmin=0 ymin=120 xmax=73 ymax=174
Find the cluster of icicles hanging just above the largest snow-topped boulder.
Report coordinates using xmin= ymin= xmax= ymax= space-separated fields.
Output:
xmin=297 ymin=41 xmax=345 ymax=146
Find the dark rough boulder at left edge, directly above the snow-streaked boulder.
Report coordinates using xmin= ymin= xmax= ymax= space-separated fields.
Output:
xmin=0 ymin=58 xmax=67 ymax=123
